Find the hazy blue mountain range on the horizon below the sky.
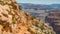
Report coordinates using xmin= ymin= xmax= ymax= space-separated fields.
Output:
xmin=19 ymin=3 xmax=60 ymax=10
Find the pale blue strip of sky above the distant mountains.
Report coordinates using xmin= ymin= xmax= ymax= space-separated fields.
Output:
xmin=17 ymin=0 xmax=60 ymax=4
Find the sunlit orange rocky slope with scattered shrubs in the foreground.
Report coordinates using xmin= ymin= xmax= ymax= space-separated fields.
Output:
xmin=0 ymin=0 xmax=55 ymax=34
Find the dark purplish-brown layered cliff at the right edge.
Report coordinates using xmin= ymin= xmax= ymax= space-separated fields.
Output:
xmin=46 ymin=9 xmax=60 ymax=34
